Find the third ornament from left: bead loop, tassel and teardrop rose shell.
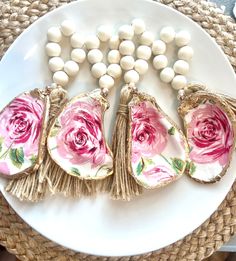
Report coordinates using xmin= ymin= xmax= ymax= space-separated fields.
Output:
xmin=107 ymin=19 xmax=188 ymax=200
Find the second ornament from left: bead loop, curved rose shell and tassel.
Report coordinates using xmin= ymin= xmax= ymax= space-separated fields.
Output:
xmin=43 ymin=22 xmax=136 ymax=197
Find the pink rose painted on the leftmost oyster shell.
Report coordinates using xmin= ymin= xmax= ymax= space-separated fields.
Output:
xmin=0 ymin=94 xmax=44 ymax=156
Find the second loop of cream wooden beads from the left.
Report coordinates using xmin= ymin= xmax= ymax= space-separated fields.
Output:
xmin=86 ymin=25 xmax=122 ymax=95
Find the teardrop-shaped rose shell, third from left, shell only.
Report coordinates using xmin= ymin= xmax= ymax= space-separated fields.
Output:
xmin=128 ymin=93 xmax=188 ymax=189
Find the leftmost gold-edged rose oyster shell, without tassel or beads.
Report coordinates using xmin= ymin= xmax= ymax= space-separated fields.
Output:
xmin=0 ymin=89 xmax=49 ymax=178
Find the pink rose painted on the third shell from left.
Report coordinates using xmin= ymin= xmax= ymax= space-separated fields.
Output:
xmin=131 ymin=101 xmax=168 ymax=162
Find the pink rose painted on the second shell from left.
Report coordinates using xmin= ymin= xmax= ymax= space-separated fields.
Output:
xmin=57 ymin=98 xmax=107 ymax=167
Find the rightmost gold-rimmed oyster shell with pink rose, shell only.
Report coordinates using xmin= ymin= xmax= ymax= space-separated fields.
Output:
xmin=178 ymin=91 xmax=236 ymax=183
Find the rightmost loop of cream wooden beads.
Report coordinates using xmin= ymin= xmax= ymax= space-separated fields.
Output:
xmin=152 ymin=26 xmax=193 ymax=90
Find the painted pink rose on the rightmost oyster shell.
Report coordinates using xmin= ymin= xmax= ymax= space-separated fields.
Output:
xmin=187 ymin=103 xmax=234 ymax=166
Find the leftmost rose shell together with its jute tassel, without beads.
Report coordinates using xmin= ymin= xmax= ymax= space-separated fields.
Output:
xmin=0 ymin=86 xmax=65 ymax=201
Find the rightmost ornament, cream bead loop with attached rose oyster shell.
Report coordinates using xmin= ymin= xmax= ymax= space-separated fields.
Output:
xmin=153 ymin=27 xmax=236 ymax=183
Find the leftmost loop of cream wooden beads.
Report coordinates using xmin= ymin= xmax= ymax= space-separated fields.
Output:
xmin=45 ymin=20 xmax=86 ymax=87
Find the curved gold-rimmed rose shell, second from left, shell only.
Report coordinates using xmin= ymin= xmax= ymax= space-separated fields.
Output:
xmin=47 ymin=90 xmax=113 ymax=180
